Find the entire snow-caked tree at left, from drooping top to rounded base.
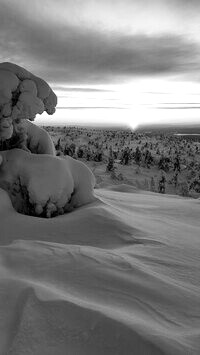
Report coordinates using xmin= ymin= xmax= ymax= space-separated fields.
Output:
xmin=0 ymin=63 xmax=95 ymax=217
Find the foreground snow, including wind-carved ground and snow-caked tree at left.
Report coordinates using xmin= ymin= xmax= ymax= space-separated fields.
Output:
xmin=0 ymin=63 xmax=200 ymax=355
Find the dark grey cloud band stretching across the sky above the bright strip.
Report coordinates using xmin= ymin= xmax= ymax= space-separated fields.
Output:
xmin=0 ymin=2 xmax=200 ymax=83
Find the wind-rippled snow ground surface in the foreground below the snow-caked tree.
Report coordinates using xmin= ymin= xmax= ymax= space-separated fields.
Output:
xmin=0 ymin=186 xmax=200 ymax=355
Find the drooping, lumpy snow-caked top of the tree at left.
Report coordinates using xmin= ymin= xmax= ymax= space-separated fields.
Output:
xmin=0 ymin=62 xmax=57 ymax=142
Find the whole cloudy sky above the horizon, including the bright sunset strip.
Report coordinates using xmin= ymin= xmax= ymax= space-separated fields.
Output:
xmin=0 ymin=0 xmax=200 ymax=128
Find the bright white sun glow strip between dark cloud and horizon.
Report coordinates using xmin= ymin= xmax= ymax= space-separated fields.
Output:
xmin=36 ymin=79 xmax=200 ymax=129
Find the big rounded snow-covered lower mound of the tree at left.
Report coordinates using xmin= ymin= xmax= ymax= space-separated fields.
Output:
xmin=0 ymin=149 xmax=95 ymax=217
